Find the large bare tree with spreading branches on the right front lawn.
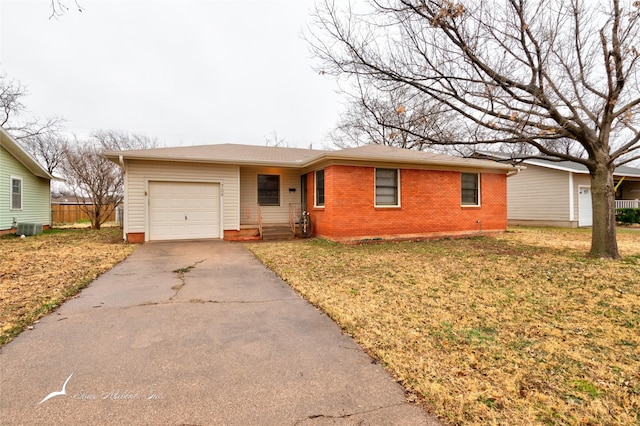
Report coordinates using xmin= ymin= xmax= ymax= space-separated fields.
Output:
xmin=308 ymin=0 xmax=640 ymax=259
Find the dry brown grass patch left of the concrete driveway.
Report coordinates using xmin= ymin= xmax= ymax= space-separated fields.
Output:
xmin=0 ymin=229 xmax=135 ymax=345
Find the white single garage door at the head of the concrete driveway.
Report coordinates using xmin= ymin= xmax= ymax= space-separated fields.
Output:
xmin=149 ymin=182 xmax=220 ymax=240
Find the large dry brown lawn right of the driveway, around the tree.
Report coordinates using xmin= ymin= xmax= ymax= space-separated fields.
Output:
xmin=249 ymin=228 xmax=640 ymax=425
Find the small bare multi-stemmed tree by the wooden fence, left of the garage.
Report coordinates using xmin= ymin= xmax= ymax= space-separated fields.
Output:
xmin=62 ymin=130 xmax=158 ymax=229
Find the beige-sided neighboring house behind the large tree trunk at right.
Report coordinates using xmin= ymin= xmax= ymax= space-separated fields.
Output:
xmin=476 ymin=152 xmax=640 ymax=228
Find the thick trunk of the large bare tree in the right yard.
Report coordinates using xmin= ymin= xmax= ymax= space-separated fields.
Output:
xmin=590 ymin=167 xmax=620 ymax=260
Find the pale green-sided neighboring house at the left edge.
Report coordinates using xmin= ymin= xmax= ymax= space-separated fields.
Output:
xmin=0 ymin=127 xmax=53 ymax=234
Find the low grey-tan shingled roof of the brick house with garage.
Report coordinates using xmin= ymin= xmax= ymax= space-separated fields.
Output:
xmin=104 ymin=144 xmax=514 ymax=172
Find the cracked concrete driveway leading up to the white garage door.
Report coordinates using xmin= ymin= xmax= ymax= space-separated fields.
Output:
xmin=0 ymin=241 xmax=438 ymax=425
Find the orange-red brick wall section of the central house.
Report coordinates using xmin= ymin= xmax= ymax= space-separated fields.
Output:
xmin=307 ymin=166 xmax=507 ymax=240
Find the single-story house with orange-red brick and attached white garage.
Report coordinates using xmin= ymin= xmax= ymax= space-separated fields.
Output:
xmin=105 ymin=144 xmax=515 ymax=242
